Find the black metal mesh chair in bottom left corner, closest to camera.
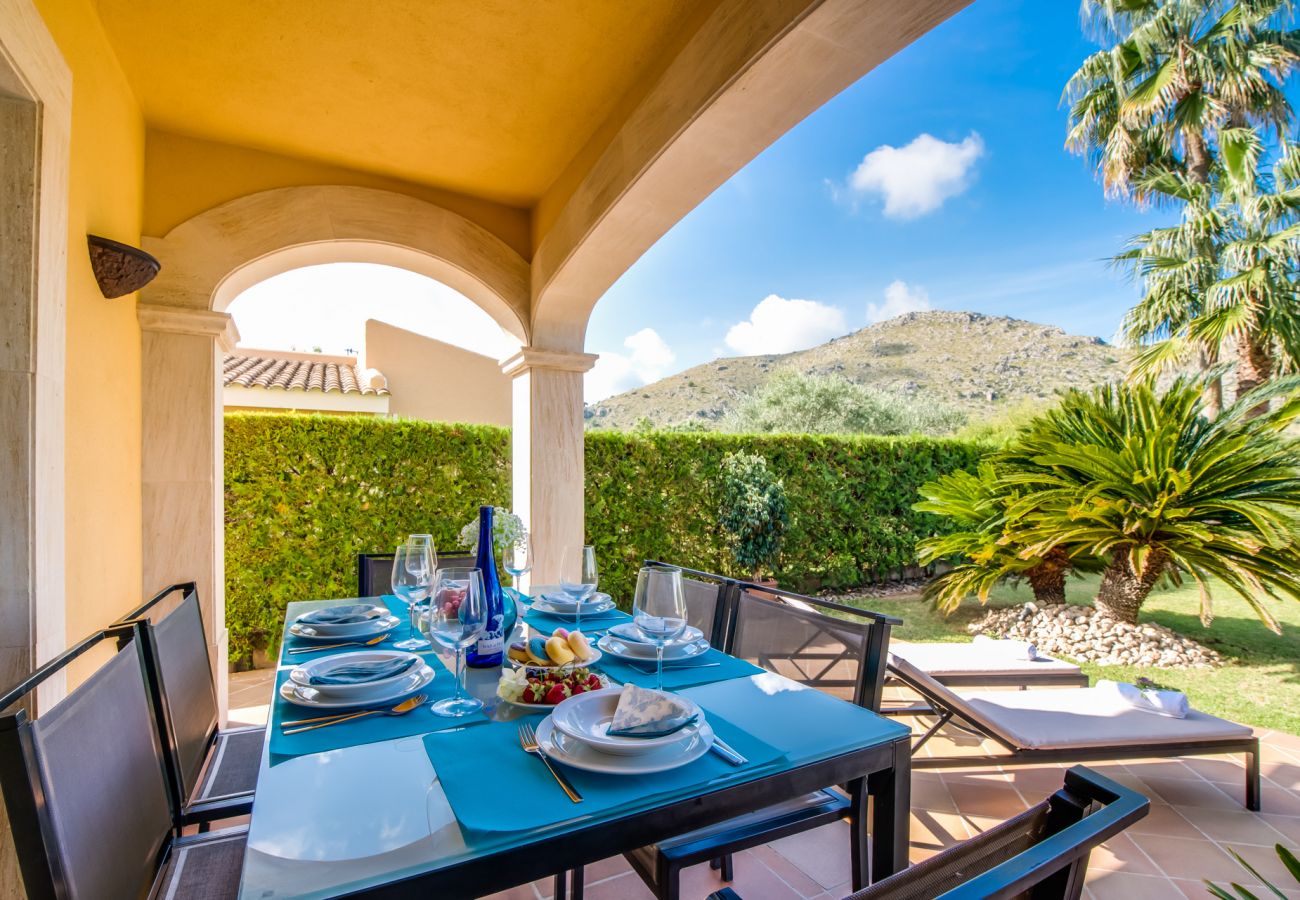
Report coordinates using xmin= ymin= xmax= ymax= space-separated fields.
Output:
xmin=0 ymin=623 xmax=247 ymax=900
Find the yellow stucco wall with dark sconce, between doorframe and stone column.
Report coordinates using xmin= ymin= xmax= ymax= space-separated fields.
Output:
xmin=36 ymin=0 xmax=144 ymax=682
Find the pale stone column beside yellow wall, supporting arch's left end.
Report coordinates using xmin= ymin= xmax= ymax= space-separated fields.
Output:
xmin=139 ymin=303 xmax=239 ymax=723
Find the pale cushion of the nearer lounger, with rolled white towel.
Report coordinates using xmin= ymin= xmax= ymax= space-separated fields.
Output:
xmin=961 ymin=688 xmax=1252 ymax=750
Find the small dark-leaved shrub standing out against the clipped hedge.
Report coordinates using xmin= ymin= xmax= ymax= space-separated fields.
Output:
xmin=718 ymin=451 xmax=790 ymax=581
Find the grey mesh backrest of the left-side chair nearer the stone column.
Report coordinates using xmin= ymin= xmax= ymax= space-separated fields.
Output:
xmin=148 ymin=590 xmax=218 ymax=801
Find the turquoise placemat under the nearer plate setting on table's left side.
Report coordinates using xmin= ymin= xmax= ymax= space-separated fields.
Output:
xmin=270 ymin=653 xmax=486 ymax=757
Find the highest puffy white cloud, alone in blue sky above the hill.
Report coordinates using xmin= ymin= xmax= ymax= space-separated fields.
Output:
xmin=849 ymin=131 xmax=984 ymax=218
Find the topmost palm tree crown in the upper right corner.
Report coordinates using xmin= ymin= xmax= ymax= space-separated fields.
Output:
xmin=1063 ymin=0 xmax=1300 ymax=199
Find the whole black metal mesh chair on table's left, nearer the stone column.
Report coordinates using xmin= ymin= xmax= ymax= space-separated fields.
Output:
xmin=120 ymin=581 xmax=267 ymax=828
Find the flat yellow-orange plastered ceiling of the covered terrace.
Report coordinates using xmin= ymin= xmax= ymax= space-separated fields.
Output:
xmin=95 ymin=0 xmax=716 ymax=207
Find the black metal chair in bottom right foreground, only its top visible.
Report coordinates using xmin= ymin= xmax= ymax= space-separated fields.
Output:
xmin=709 ymin=766 xmax=1151 ymax=900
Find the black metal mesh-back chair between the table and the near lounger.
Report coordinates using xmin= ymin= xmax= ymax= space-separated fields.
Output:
xmin=624 ymin=583 xmax=902 ymax=900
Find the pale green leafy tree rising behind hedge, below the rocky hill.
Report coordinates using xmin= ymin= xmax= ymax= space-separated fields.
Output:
xmin=725 ymin=372 xmax=966 ymax=434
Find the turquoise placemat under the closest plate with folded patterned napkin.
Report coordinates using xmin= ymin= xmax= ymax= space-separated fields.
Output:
xmin=424 ymin=709 xmax=784 ymax=832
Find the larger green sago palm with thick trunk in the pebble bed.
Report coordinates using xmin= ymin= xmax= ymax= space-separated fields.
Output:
xmin=998 ymin=376 xmax=1300 ymax=631
